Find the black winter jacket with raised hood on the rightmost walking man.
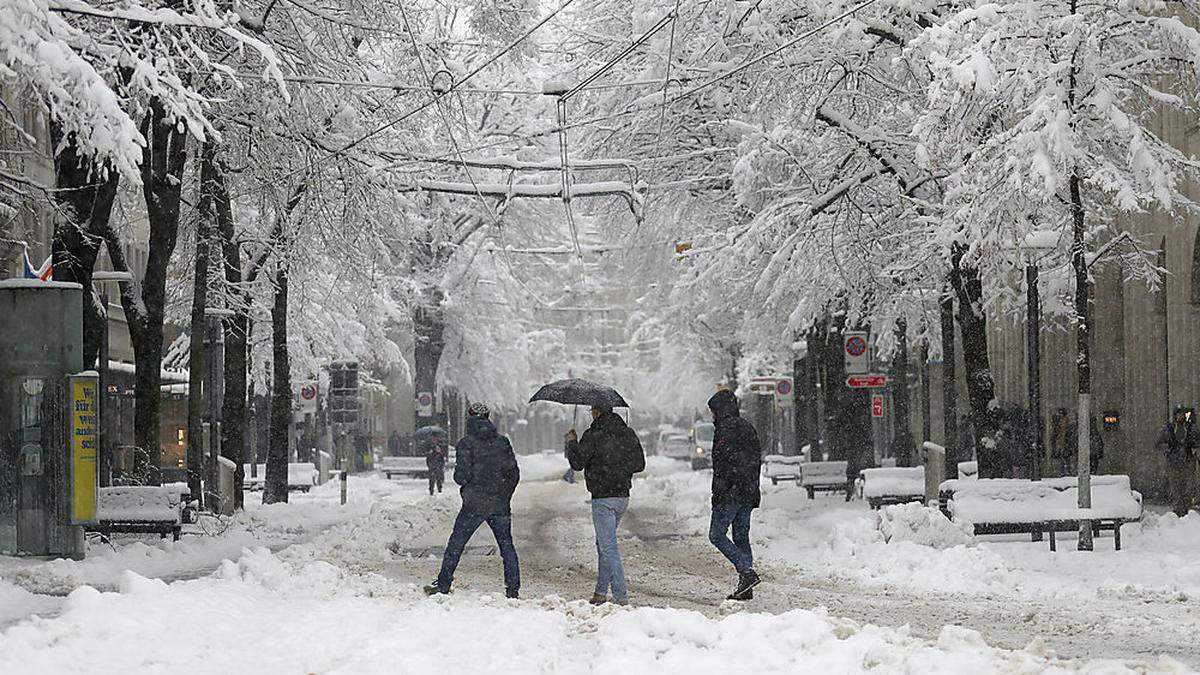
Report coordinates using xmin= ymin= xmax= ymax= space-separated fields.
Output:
xmin=708 ymin=390 xmax=762 ymax=507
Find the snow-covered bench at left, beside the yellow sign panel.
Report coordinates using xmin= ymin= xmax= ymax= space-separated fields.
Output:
xmin=88 ymin=485 xmax=184 ymax=542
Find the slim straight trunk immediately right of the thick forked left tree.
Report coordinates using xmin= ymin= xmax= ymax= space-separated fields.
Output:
xmin=187 ymin=143 xmax=215 ymax=508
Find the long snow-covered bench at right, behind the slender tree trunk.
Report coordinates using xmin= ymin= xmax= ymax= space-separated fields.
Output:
xmin=940 ymin=476 xmax=1142 ymax=550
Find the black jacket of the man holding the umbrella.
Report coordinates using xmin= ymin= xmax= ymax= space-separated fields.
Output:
xmin=566 ymin=412 xmax=646 ymax=500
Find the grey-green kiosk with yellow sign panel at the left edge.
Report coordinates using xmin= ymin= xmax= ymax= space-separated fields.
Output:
xmin=0 ymin=279 xmax=89 ymax=558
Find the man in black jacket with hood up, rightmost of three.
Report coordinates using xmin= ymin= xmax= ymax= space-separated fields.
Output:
xmin=708 ymin=389 xmax=762 ymax=601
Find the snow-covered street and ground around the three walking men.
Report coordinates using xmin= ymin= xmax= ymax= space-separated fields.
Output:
xmin=0 ymin=455 xmax=1200 ymax=674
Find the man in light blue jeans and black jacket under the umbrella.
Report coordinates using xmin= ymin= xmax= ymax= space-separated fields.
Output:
xmin=566 ymin=406 xmax=646 ymax=604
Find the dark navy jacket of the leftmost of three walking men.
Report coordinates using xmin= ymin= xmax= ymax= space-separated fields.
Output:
xmin=454 ymin=417 xmax=521 ymax=514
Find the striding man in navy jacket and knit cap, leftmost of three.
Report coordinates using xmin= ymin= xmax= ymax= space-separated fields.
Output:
xmin=425 ymin=402 xmax=521 ymax=598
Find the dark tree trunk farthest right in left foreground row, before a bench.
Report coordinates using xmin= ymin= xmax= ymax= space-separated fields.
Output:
xmin=263 ymin=261 xmax=292 ymax=504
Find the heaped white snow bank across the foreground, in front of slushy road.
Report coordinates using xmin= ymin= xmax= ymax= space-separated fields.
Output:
xmin=0 ymin=550 xmax=1184 ymax=674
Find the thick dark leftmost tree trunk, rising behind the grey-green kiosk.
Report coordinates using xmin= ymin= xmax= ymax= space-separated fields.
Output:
xmin=49 ymin=123 xmax=119 ymax=369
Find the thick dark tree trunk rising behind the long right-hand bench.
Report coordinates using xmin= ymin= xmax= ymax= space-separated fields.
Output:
xmin=950 ymin=244 xmax=1007 ymax=478
